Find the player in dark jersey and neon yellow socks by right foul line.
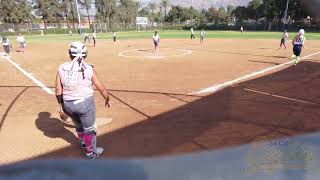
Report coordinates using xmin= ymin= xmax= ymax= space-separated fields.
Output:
xmin=291 ymin=29 xmax=306 ymax=65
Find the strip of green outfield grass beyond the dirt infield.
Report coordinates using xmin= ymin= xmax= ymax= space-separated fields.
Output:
xmin=9 ymin=31 xmax=320 ymax=42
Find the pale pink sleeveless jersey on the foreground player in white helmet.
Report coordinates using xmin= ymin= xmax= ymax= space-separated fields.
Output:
xmin=59 ymin=62 xmax=93 ymax=101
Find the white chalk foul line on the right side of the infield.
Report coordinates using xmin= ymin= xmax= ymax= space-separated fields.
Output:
xmin=191 ymin=51 xmax=320 ymax=94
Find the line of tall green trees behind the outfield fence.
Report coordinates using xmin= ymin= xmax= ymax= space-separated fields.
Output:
xmin=0 ymin=0 xmax=317 ymax=29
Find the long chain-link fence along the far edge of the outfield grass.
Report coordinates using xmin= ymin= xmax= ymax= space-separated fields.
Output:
xmin=0 ymin=21 xmax=320 ymax=35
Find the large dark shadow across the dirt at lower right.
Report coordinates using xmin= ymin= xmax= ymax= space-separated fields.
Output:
xmin=25 ymin=62 xmax=320 ymax=158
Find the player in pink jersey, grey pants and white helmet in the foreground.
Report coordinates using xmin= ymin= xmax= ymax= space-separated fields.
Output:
xmin=56 ymin=42 xmax=110 ymax=159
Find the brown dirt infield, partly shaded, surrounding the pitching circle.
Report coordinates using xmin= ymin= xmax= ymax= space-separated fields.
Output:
xmin=0 ymin=39 xmax=320 ymax=164
